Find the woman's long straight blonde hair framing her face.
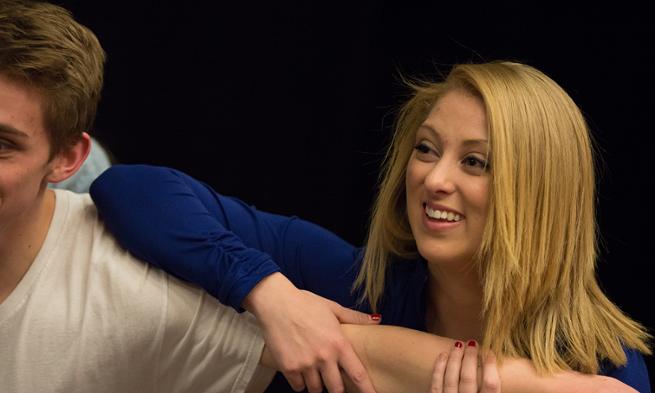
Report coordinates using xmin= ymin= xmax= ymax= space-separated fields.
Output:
xmin=355 ymin=62 xmax=650 ymax=373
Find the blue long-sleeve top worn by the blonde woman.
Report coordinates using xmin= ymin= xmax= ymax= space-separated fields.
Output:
xmin=90 ymin=165 xmax=650 ymax=392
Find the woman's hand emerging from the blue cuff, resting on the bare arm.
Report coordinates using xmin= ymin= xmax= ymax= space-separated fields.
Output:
xmin=243 ymin=273 xmax=380 ymax=393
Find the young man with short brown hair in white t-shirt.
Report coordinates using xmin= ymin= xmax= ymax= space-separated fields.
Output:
xmin=0 ymin=0 xmax=274 ymax=393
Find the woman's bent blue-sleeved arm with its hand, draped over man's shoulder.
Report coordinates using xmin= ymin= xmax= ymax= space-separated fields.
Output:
xmin=91 ymin=165 xmax=379 ymax=392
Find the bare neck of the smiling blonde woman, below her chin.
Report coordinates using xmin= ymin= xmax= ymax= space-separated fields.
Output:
xmin=426 ymin=263 xmax=482 ymax=341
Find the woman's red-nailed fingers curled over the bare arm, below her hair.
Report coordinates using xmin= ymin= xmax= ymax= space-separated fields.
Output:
xmin=430 ymin=340 xmax=500 ymax=393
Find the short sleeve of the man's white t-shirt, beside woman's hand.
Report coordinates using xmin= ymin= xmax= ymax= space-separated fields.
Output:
xmin=153 ymin=277 xmax=274 ymax=393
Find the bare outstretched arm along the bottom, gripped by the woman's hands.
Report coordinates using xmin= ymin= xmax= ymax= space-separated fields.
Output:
xmin=261 ymin=325 xmax=637 ymax=393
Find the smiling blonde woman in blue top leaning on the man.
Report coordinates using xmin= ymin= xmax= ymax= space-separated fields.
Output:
xmin=91 ymin=62 xmax=650 ymax=391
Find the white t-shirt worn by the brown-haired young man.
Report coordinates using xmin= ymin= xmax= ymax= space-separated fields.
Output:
xmin=0 ymin=190 xmax=272 ymax=393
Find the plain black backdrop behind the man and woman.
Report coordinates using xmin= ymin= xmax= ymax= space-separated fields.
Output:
xmin=60 ymin=0 xmax=655 ymax=384
